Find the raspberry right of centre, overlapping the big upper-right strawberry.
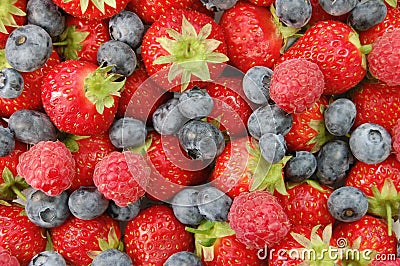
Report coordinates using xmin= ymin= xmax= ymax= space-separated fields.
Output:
xmin=270 ymin=59 xmax=325 ymax=113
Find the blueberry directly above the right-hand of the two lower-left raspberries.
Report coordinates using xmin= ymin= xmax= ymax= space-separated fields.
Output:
xmin=109 ymin=117 xmax=147 ymax=149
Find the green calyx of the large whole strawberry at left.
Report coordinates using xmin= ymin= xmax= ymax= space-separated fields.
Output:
xmin=84 ymin=65 xmax=126 ymax=114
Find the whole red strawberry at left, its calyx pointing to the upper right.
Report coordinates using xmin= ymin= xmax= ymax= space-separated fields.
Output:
xmin=42 ymin=60 xmax=125 ymax=136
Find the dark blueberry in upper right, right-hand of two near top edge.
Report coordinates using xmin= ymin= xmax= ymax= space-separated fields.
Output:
xmin=348 ymin=0 xmax=387 ymax=31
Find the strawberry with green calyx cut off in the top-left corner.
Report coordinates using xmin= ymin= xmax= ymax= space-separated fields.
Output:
xmin=0 ymin=0 xmax=27 ymax=49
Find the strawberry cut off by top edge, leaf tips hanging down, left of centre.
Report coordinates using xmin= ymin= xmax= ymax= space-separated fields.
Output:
xmin=53 ymin=0 xmax=129 ymax=20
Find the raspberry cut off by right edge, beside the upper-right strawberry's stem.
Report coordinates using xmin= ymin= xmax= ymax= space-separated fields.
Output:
xmin=367 ymin=29 xmax=400 ymax=86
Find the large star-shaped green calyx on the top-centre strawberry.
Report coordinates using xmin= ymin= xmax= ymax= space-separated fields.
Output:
xmin=154 ymin=16 xmax=229 ymax=91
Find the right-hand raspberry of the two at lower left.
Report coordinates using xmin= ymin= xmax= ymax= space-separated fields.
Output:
xmin=93 ymin=151 xmax=150 ymax=207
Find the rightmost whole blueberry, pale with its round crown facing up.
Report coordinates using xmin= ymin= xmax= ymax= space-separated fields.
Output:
xmin=349 ymin=123 xmax=392 ymax=164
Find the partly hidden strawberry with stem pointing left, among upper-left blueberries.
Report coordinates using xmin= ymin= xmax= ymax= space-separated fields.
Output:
xmin=53 ymin=15 xmax=110 ymax=64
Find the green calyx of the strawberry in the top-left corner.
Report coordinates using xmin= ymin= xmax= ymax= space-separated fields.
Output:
xmin=0 ymin=0 xmax=26 ymax=34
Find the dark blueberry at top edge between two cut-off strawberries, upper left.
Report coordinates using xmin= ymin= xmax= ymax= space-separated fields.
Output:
xmin=26 ymin=0 xmax=65 ymax=37
